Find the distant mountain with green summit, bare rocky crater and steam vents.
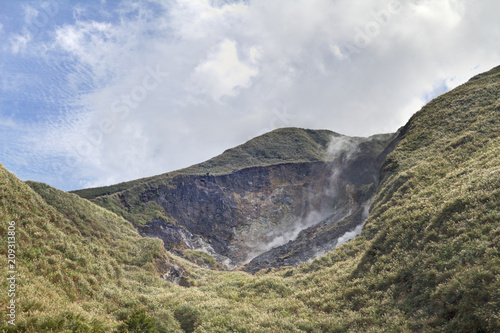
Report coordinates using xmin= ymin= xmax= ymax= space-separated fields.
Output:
xmin=74 ymin=128 xmax=394 ymax=272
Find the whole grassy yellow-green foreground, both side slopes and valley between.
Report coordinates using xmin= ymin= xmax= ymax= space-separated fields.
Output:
xmin=0 ymin=63 xmax=500 ymax=332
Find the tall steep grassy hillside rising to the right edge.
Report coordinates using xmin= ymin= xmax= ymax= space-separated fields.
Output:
xmin=351 ymin=67 xmax=500 ymax=332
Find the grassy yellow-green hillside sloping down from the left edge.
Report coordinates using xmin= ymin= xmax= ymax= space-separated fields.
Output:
xmin=0 ymin=165 xmax=188 ymax=332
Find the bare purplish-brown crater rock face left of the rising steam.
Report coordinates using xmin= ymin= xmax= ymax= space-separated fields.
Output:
xmin=140 ymin=162 xmax=338 ymax=268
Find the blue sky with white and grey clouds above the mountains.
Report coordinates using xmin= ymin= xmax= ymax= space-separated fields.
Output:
xmin=0 ymin=0 xmax=500 ymax=190
